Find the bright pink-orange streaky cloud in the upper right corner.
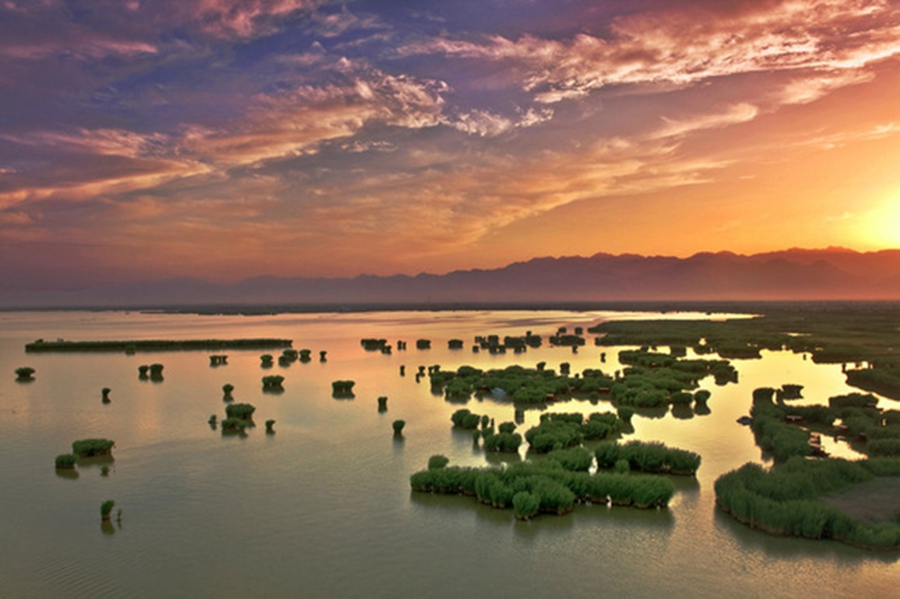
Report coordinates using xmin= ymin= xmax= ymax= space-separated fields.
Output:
xmin=408 ymin=0 xmax=900 ymax=104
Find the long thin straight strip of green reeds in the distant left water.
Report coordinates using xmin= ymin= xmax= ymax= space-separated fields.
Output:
xmin=25 ymin=339 xmax=293 ymax=353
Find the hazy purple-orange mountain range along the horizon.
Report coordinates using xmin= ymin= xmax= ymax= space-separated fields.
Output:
xmin=0 ymin=248 xmax=900 ymax=309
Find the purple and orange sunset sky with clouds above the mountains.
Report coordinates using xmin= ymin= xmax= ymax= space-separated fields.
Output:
xmin=0 ymin=0 xmax=900 ymax=290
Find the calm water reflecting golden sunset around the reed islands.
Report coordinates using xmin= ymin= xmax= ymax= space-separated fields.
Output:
xmin=0 ymin=312 xmax=900 ymax=597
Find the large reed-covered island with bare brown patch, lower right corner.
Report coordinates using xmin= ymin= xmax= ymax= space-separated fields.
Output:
xmin=715 ymin=388 xmax=900 ymax=549
